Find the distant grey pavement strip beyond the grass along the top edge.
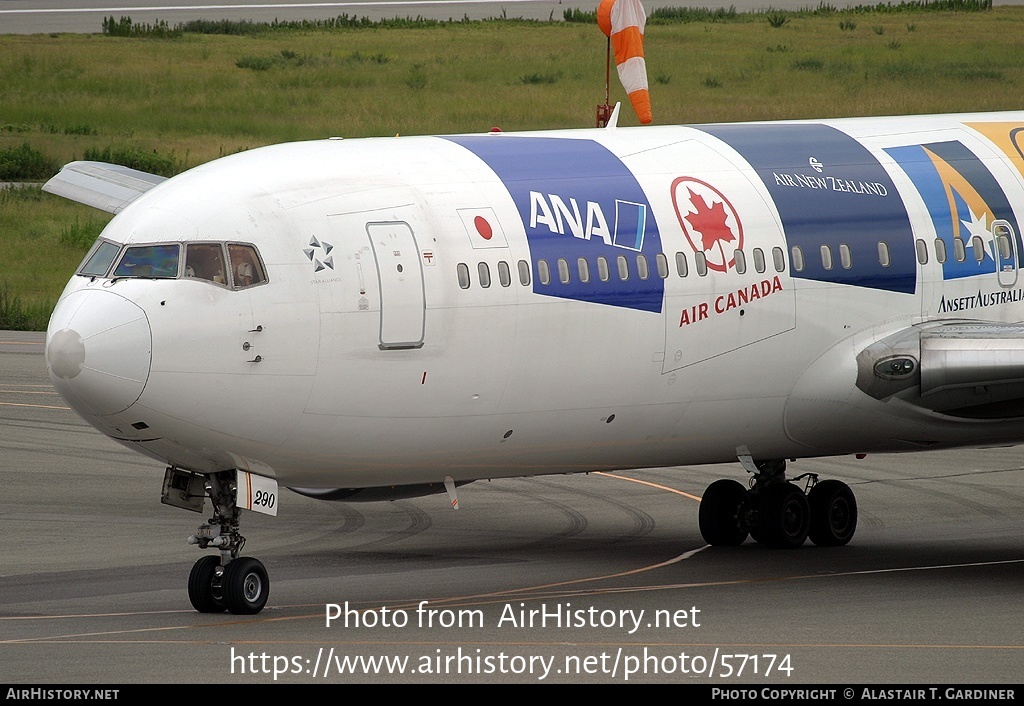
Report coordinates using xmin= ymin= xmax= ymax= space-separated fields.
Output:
xmin=0 ymin=0 xmax=1024 ymax=34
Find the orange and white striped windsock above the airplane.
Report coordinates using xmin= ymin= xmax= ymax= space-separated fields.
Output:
xmin=597 ymin=0 xmax=651 ymax=125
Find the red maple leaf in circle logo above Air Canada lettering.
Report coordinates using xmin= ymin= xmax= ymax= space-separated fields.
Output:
xmin=672 ymin=176 xmax=743 ymax=273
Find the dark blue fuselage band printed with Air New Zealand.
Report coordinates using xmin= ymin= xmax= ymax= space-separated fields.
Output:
xmin=694 ymin=124 xmax=918 ymax=294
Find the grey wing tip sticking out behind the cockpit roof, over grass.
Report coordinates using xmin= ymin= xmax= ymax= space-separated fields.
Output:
xmin=43 ymin=162 xmax=167 ymax=213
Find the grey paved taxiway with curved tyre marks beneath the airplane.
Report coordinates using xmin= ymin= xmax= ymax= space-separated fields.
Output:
xmin=0 ymin=332 xmax=1024 ymax=686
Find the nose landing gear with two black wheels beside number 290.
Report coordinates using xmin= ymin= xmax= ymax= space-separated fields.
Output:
xmin=188 ymin=471 xmax=270 ymax=615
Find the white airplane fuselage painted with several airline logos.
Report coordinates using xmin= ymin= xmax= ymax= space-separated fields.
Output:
xmin=48 ymin=113 xmax=1024 ymax=488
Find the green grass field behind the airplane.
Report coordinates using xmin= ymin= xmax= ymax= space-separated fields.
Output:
xmin=0 ymin=7 xmax=1024 ymax=328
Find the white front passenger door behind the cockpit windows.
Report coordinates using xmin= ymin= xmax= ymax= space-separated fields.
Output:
xmin=367 ymin=221 xmax=426 ymax=350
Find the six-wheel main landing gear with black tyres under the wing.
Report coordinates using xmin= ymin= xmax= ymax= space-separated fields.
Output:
xmin=699 ymin=456 xmax=857 ymax=549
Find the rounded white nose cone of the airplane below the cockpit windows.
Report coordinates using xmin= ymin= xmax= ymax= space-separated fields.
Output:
xmin=46 ymin=289 xmax=153 ymax=416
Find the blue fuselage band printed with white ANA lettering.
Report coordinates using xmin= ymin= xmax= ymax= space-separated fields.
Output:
xmin=445 ymin=135 xmax=665 ymax=313
